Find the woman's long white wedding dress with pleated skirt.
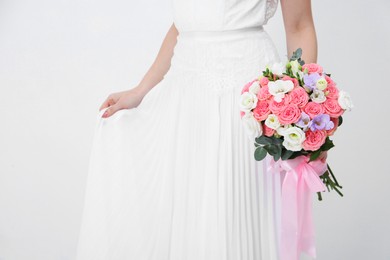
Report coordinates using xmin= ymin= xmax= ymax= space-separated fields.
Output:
xmin=77 ymin=0 xmax=280 ymax=260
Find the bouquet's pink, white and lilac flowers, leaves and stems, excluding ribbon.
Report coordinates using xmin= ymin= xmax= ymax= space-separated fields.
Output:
xmin=240 ymin=49 xmax=353 ymax=200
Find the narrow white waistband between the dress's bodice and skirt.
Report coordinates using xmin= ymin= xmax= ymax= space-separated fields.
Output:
xmin=179 ymin=26 xmax=264 ymax=38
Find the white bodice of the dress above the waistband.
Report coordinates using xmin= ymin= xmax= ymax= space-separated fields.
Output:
xmin=173 ymin=0 xmax=278 ymax=31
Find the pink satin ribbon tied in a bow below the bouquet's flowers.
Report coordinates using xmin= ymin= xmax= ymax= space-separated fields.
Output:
xmin=268 ymin=156 xmax=327 ymax=260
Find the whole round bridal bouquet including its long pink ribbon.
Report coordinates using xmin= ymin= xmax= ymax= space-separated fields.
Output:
xmin=240 ymin=49 xmax=353 ymax=260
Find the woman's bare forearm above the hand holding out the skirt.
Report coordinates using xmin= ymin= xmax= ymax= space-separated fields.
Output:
xmin=136 ymin=24 xmax=178 ymax=96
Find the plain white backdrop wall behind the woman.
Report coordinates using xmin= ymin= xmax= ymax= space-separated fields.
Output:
xmin=0 ymin=0 xmax=390 ymax=260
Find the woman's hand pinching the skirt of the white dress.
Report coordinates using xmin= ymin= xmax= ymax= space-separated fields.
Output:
xmin=99 ymin=88 xmax=145 ymax=118
